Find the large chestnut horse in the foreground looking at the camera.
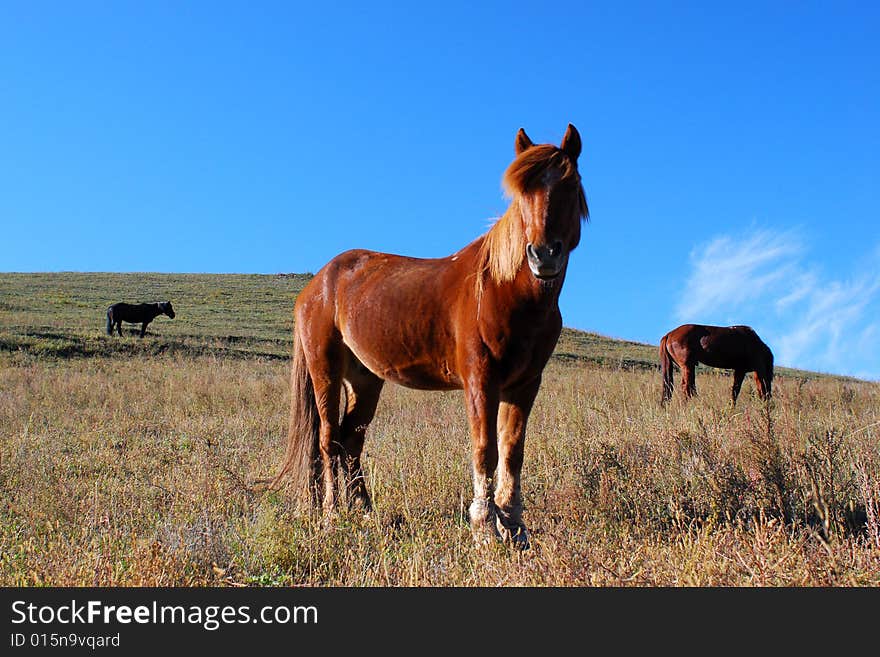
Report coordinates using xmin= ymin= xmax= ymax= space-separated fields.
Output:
xmin=272 ymin=125 xmax=588 ymax=548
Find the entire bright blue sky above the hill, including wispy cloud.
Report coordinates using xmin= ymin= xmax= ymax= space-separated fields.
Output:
xmin=0 ymin=1 xmax=880 ymax=379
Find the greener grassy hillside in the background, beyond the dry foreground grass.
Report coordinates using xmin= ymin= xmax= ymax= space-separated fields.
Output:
xmin=0 ymin=272 xmax=822 ymax=378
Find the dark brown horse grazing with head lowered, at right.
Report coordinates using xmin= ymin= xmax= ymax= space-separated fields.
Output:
xmin=660 ymin=324 xmax=773 ymax=406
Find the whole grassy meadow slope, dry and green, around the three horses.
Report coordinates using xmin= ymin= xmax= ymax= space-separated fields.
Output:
xmin=0 ymin=273 xmax=880 ymax=586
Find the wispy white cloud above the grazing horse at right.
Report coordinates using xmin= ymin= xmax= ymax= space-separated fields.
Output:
xmin=676 ymin=230 xmax=880 ymax=379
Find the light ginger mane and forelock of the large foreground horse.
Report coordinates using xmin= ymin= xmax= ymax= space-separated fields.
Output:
xmin=477 ymin=144 xmax=590 ymax=291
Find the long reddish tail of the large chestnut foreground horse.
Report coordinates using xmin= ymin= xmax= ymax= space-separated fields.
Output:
xmin=263 ymin=329 xmax=321 ymax=499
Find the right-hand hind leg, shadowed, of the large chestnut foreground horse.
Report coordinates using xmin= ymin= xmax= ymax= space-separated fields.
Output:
xmin=340 ymin=355 xmax=384 ymax=512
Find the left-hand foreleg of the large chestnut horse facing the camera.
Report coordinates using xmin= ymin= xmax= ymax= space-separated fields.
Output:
xmin=465 ymin=374 xmax=499 ymax=543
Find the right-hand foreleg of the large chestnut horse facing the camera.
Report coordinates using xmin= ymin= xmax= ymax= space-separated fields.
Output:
xmin=495 ymin=377 xmax=541 ymax=550
